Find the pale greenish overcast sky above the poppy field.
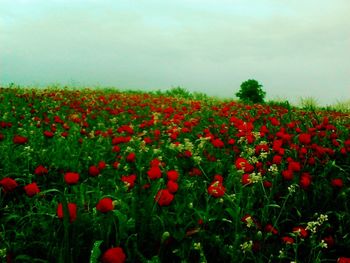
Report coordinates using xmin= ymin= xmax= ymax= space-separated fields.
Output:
xmin=0 ymin=0 xmax=350 ymax=105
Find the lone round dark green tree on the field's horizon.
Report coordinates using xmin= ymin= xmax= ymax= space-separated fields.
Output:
xmin=236 ymin=79 xmax=266 ymax=103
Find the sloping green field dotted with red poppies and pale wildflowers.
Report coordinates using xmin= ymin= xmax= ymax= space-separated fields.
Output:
xmin=0 ymin=88 xmax=350 ymax=263
